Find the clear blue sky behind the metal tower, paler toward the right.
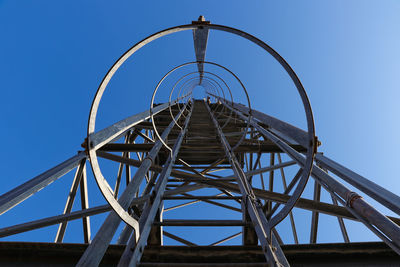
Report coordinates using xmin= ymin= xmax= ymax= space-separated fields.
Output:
xmin=0 ymin=0 xmax=400 ymax=247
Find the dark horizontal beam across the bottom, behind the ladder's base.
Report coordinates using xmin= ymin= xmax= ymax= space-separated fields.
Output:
xmin=0 ymin=242 xmax=400 ymax=267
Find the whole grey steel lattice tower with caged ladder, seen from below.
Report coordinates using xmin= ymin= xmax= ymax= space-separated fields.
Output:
xmin=0 ymin=17 xmax=400 ymax=266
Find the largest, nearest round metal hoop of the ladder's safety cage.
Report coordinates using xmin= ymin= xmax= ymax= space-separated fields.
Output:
xmin=87 ymin=24 xmax=316 ymax=229
